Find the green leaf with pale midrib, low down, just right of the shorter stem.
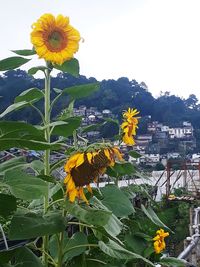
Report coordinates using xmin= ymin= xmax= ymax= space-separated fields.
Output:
xmin=64 ymin=232 xmax=88 ymax=261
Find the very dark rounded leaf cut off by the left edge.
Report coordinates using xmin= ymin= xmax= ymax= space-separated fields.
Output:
xmin=0 ymin=194 xmax=17 ymax=217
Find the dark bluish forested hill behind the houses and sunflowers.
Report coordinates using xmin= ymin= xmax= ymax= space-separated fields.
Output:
xmin=0 ymin=70 xmax=200 ymax=128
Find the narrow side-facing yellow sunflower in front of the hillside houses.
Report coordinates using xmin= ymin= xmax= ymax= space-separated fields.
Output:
xmin=121 ymin=108 xmax=139 ymax=145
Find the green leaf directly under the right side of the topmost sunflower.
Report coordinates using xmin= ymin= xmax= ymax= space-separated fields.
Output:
xmin=53 ymin=58 xmax=79 ymax=77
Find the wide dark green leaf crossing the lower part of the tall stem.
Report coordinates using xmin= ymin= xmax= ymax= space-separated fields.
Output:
xmin=9 ymin=212 xmax=66 ymax=240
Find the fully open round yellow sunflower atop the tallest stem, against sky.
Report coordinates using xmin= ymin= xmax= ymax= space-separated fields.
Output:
xmin=31 ymin=14 xmax=80 ymax=65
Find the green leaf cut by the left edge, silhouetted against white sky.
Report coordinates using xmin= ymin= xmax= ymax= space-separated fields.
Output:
xmin=0 ymin=57 xmax=30 ymax=71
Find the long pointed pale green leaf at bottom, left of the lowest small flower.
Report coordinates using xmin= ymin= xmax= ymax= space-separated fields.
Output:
xmin=99 ymin=239 xmax=154 ymax=266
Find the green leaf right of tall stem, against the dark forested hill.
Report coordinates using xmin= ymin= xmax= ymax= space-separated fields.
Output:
xmin=63 ymin=83 xmax=99 ymax=99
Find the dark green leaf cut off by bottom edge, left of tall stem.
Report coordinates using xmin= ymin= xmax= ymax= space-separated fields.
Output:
xmin=14 ymin=247 xmax=43 ymax=267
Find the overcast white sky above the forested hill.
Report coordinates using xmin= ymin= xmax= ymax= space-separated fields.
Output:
xmin=0 ymin=0 xmax=200 ymax=99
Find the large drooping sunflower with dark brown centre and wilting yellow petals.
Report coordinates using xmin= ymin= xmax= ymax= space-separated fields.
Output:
xmin=64 ymin=147 xmax=123 ymax=204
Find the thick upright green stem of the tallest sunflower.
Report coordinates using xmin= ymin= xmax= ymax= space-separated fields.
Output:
xmin=43 ymin=66 xmax=51 ymax=267
